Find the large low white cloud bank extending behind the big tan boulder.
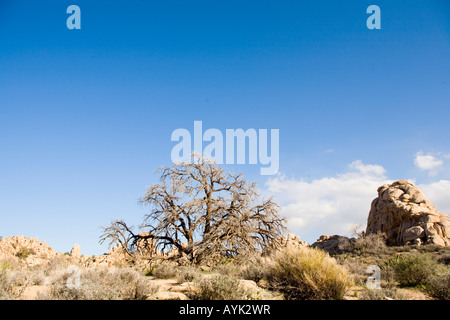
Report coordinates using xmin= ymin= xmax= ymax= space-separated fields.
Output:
xmin=266 ymin=160 xmax=450 ymax=243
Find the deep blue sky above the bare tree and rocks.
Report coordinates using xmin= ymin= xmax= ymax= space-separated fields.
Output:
xmin=0 ymin=0 xmax=450 ymax=255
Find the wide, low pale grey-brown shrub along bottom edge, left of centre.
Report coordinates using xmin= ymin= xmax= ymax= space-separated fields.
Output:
xmin=46 ymin=268 xmax=159 ymax=300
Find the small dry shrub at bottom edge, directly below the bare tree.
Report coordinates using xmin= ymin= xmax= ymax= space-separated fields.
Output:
xmin=195 ymin=275 xmax=252 ymax=300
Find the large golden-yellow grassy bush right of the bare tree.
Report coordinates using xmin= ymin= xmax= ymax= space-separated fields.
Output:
xmin=266 ymin=247 xmax=353 ymax=300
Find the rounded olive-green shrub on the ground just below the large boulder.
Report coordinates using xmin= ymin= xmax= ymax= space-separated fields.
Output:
xmin=387 ymin=253 xmax=442 ymax=287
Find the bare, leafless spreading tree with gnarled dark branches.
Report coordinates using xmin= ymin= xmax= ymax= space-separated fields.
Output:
xmin=101 ymin=154 xmax=286 ymax=264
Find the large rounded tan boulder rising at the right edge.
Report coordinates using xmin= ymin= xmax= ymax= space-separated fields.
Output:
xmin=366 ymin=180 xmax=450 ymax=246
